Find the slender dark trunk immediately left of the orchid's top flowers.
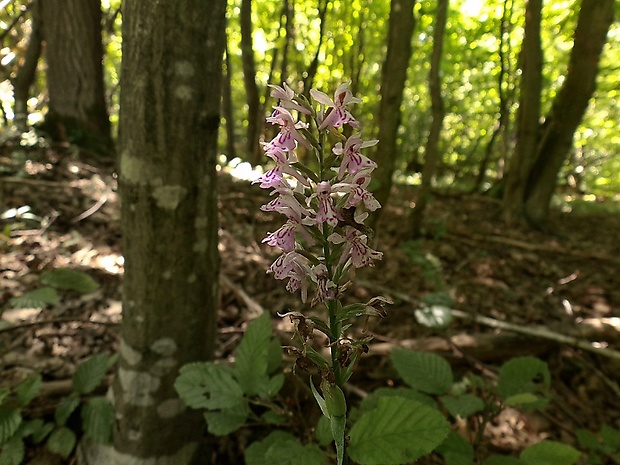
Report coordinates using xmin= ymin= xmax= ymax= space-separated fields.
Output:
xmin=239 ymin=0 xmax=262 ymax=165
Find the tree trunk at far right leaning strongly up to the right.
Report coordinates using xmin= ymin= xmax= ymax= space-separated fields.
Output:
xmin=504 ymin=0 xmax=614 ymax=226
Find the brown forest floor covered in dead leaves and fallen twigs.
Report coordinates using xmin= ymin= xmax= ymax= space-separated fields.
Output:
xmin=0 ymin=143 xmax=620 ymax=465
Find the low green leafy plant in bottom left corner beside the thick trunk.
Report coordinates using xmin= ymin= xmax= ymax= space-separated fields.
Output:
xmin=0 ymin=354 xmax=116 ymax=465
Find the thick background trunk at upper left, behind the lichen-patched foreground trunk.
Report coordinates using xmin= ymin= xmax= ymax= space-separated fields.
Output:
xmin=39 ymin=0 xmax=113 ymax=154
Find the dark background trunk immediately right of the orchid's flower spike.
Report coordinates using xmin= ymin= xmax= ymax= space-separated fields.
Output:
xmin=371 ymin=0 xmax=415 ymax=225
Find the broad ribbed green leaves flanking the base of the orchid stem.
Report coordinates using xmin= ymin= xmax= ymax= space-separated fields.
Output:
xmin=175 ymin=308 xmax=449 ymax=465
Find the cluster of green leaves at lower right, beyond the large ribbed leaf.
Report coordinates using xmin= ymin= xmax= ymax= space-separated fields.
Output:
xmin=386 ymin=349 xmax=581 ymax=465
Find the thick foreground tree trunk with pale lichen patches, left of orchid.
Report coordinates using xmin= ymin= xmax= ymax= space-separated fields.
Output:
xmin=81 ymin=0 xmax=226 ymax=465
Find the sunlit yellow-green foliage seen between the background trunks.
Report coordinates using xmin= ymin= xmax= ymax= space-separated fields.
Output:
xmin=0 ymin=0 xmax=620 ymax=198
